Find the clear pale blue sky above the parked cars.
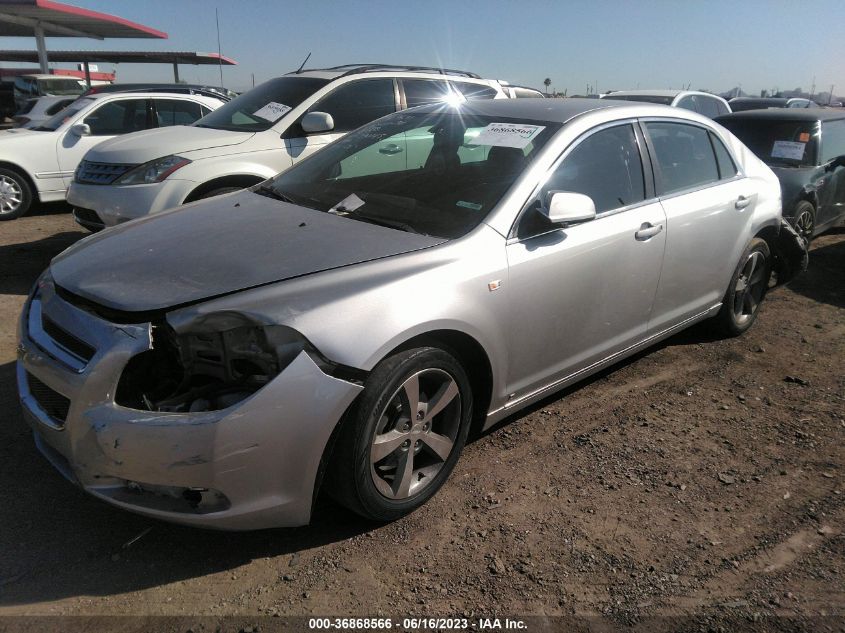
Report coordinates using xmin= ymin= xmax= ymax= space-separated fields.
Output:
xmin=2 ymin=0 xmax=845 ymax=95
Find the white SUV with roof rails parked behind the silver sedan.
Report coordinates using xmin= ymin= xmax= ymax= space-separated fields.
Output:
xmin=68 ymin=64 xmax=507 ymax=230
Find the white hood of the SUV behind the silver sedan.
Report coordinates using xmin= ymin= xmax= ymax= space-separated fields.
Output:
xmin=85 ymin=125 xmax=254 ymax=165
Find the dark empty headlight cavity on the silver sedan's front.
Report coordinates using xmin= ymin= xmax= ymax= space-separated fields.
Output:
xmin=115 ymin=313 xmax=310 ymax=412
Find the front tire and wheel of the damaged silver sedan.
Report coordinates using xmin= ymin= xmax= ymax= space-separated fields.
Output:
xmin=326 ymin=347 xmax=472 ymax=521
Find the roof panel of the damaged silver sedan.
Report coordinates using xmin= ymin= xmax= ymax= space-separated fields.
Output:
xmin=403 ymin=98 xmax=672 ymax=123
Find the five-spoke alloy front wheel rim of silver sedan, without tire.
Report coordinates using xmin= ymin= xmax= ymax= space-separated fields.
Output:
xmin=370 ymin=369 xmax=461 ymax=500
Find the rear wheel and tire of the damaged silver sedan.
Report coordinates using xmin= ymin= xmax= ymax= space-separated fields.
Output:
xmin=714 ymin=237 xmax=772 ymax=336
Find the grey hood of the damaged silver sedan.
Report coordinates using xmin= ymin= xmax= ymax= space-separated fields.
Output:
xmin=50 ymin=191 xmax=445 ymax=312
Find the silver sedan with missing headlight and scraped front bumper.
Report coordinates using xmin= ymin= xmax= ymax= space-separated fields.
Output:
xmin=17 ymin=99 xmax=785 ymax=529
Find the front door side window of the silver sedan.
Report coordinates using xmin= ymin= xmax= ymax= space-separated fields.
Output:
xmin=542 ymin=125 xmax=645 ymax=213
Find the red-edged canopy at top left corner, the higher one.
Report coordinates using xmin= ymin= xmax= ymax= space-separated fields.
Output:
xmin=0 ymin=0 xmax=167 ymax=73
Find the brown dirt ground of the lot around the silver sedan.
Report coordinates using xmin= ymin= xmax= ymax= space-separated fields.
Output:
xmin=0 ymin=205 xmax=845 ymax=631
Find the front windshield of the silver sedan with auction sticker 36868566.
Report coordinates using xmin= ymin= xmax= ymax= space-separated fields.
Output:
xmin=266 ymin=107 xmax=560 ymax=238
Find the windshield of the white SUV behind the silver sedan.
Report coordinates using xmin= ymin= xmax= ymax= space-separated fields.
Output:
xmin=194 ymin=77 xmax=329 ymax=132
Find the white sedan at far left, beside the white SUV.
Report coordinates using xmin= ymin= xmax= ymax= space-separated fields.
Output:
xmin=0 ymin=92 xmax=224 ymax=220
